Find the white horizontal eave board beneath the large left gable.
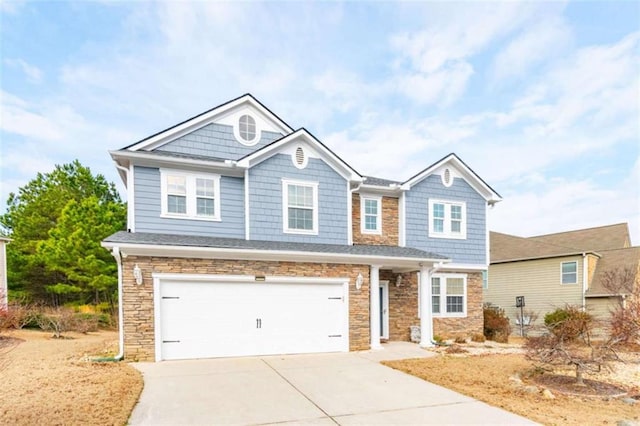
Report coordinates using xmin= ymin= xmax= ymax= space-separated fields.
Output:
xmin=109 ymin=151 xmax=244 ymax=177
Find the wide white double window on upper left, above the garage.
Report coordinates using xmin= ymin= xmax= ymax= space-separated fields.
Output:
xmin=160 ymin=169 xmax=220 ymax=220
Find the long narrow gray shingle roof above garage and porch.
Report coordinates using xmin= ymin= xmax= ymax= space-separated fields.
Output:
xmin=104 ymin=231 xmax=448 ymax=260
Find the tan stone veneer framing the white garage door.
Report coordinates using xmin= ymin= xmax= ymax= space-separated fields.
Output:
xmin=122 ymin=256 xmax=370 ymax=361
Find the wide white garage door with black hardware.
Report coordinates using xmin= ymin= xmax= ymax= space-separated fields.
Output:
xmin=156 ymin=280 xmax=348 ymax=360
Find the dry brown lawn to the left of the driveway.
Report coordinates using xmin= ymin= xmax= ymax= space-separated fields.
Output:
xmin=0 ymin=330 xmax=143 ymax=425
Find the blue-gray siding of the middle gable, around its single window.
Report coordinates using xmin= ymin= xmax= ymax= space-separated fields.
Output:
xmin=249 ymin=154 xmax=348 ymax=244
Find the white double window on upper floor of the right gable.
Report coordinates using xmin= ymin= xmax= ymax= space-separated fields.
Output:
xmin=429 ymin=200 xmax=467 ymax=239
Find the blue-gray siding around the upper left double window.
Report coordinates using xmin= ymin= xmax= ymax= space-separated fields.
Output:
xmin=134 ymin=166 xmax=244 ymax=238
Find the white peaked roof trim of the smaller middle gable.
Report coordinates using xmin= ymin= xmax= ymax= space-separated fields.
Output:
xmin=238 ymin=129 xmax=362 ymax=182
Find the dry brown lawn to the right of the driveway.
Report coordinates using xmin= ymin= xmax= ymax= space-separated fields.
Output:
xmin=384 ymin=342 xmax=640 ymax=425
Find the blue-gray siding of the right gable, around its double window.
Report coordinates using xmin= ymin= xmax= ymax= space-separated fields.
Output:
xmin=405 ymin=175 xmax=487 ymax=265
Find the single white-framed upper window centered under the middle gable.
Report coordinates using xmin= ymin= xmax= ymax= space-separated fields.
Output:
xmin=282 ymin=180 xmax=318 ymax=235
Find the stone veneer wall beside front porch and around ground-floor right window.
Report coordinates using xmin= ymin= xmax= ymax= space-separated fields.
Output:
xmin=380 ymin=270 xmax=484 ymax=341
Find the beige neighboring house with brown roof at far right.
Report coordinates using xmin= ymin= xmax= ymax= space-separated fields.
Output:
xmin=483 ymin=223 xmax=640 ymax=332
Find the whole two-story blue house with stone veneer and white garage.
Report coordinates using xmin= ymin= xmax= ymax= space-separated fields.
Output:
xmin=103 ymin=94 xmax=500 ymax=361
